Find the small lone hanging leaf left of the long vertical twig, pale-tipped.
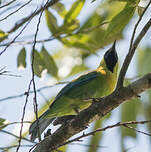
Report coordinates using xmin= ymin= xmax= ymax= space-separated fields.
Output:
xmin=17 ymin=47 xmax=26 ymax=69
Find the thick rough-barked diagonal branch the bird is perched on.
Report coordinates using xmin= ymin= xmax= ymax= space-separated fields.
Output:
xmin=33 ymin=73 xmax=151 ymax=152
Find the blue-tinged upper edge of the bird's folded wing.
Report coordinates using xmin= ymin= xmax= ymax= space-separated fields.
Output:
xmin=54 ymin=71 xmax=99 ymax=101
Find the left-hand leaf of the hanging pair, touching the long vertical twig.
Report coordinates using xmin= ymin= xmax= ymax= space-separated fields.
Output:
xmin=33 ymin=50 xmax=46 ymax=77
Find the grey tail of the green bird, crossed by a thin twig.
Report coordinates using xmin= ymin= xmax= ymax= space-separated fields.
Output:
xmin=29 ymin=112 xmax=55 ymax=141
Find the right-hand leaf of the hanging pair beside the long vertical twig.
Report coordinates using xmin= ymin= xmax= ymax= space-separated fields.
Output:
xmin=40 ymin=47 xmax=58 ymax=77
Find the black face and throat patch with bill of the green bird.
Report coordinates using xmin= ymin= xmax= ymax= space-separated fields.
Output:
xmin=104 ymin=42 xmax=118 ymax=73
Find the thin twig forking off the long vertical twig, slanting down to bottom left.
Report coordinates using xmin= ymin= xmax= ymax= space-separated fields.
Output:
xmin=16 ymin=81 xmax=32 ymax=152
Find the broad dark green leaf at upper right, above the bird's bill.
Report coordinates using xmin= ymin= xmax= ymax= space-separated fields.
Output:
xmin=104 ymin=5 xmax=136 ymax=40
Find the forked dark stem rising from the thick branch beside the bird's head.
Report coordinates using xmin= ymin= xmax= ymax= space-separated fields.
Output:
xmin=117 ymin=1 xmax=151 ymax=89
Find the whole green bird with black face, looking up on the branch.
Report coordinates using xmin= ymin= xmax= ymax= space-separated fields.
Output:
xmin=29 ymin=42 xmax=118 ymax=141
